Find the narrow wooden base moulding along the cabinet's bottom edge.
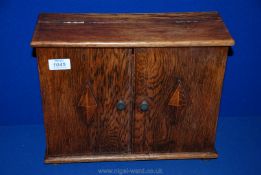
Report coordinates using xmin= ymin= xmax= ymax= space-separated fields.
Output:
xmin=45 ymin=152 xmax=218 ymax=163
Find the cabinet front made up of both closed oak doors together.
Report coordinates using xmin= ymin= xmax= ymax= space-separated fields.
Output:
xmin=37 ymin=47 xmax=227 ymax=157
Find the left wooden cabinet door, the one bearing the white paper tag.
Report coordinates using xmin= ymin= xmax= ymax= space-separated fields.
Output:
xmin=37 ymin=48 xmax=132 ymax=157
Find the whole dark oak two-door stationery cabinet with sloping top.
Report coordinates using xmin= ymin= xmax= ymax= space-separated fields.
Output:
xmin=31 ymin=12 xmax=234 ymax=163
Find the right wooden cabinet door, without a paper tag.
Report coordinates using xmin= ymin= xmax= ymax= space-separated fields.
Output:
xmin=132 ymin=47 xmax=227 ymax=153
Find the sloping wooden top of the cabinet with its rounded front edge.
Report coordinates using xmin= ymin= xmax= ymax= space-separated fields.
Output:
xmin=31 ymin=12 xmax=234 ymax=47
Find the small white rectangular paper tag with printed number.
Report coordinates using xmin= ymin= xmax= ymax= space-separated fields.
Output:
xmin=48 ymin=58 xmax=71 ymax=70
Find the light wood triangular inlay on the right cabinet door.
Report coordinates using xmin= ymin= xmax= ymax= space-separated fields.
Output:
xmin=168 ymin=83 xmax=187 ymax=107
